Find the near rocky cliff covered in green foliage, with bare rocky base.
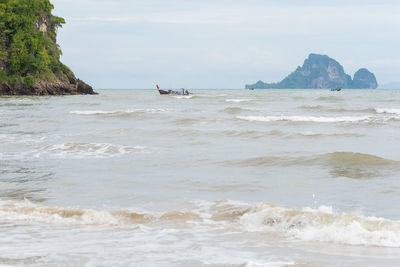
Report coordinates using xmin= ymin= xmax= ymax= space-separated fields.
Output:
xmin=0 ymin=0 xmax=95 ymax=95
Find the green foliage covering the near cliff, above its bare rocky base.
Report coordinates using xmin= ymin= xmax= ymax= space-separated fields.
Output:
xmin=0 ymin=0 xmax=65 ymax=85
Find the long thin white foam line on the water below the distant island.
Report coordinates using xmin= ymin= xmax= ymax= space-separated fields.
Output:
xmin=237 ymin=116 xmax=374 ymax=123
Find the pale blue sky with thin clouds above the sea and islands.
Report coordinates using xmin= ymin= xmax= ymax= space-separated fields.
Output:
xmin=51 ymin=0 xmax=400 ymax=89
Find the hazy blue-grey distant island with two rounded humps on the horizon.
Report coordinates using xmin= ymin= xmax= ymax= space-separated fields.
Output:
xmin=246 ymin=54 xmax=378 ymax=89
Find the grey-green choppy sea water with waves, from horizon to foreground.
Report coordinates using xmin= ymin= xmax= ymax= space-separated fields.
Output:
xmin=0 ymin=90 xmax=400 ymax=267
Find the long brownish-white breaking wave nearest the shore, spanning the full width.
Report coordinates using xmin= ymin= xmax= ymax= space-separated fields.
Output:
xmin=0 ymin=201 xmax=400 ymax=248
